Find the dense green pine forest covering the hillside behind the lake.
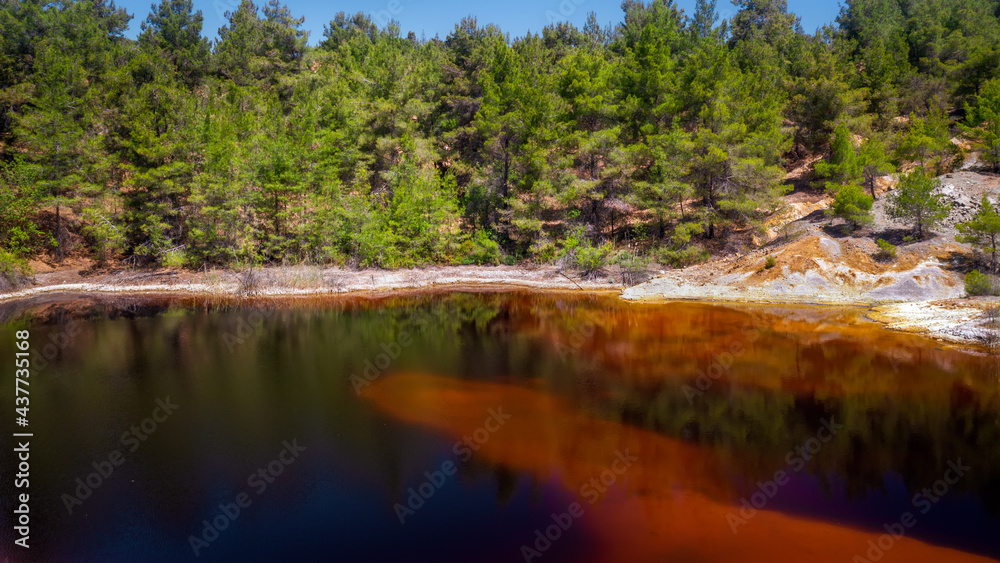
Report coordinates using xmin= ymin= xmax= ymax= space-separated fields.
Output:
xmin=0 ymin=0 xmax=1000 ymax=272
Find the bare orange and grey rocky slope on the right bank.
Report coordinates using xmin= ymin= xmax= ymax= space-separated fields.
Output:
xmin=622 ymin=165 xmax=1000 ymax=346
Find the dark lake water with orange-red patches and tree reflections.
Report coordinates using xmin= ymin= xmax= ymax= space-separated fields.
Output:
xmin=0 ymin=292 xmax=1000 ymax=562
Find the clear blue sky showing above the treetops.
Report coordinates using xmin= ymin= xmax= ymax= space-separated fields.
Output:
xmin=115 ymin=0 xmax=840 ymax=45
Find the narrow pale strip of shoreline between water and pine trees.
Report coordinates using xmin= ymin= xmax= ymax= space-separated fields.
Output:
xmin=0 ymin=266 xmax=998 ymax=350
